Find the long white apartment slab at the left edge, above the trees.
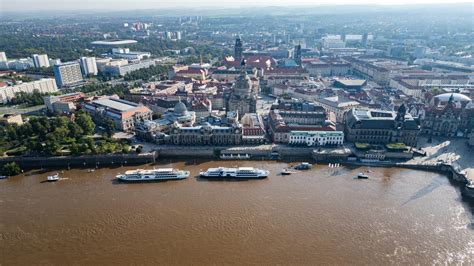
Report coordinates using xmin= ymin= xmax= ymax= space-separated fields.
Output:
xmin=0 ymin=78 xmax=58 ymax=103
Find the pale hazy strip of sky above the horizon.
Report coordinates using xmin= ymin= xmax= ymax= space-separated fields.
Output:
xmin=0 ymin=0 xmax=474 ymax=12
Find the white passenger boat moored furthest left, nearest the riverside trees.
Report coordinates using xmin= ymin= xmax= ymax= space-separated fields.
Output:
xmin=117 ymin=168 xmax=189 ymax=182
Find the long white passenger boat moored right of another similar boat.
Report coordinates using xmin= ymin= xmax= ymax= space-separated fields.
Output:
xmin=199 ymin=167 xmax=270 ymax=179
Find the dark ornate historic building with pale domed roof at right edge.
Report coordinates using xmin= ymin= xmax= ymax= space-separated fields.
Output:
xmin=421 ymin=93 xmax=474 ymax=137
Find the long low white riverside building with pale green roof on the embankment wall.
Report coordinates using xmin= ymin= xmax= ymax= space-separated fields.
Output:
xmin=288 ymin=131 xmax=344 ymax=147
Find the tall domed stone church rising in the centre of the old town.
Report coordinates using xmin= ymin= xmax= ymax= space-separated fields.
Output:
xmin=227 ymin=61 xmax=258 ymax=116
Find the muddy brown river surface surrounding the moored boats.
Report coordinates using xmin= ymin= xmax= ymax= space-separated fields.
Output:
xmin=0 ymin=161 xmax=474 ymax=265
